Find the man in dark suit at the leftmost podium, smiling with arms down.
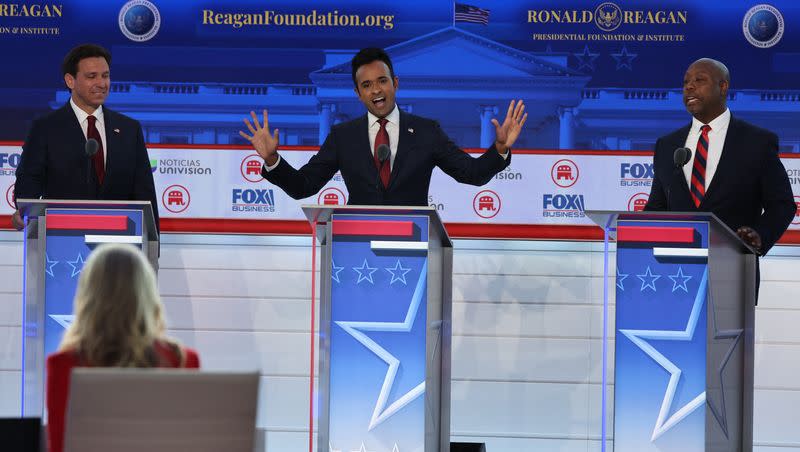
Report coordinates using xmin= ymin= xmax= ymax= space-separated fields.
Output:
xmin=12 ymin=44 xmax=158 ymax=229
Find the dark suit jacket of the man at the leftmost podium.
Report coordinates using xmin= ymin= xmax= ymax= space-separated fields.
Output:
xmin=14 ymin=103 xmax=158 ymax=225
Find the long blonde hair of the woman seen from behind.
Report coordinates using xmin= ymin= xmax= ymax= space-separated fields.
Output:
xmin=59 ymin=244 xmax=183 ymax=367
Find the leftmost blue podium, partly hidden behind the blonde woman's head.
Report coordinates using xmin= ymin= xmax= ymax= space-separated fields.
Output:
xmin=17 ymin=199 xmax=158 ymax=417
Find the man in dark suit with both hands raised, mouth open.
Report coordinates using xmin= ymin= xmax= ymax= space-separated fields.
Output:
xmin=239 ymin=48 xmax=527 ymax=206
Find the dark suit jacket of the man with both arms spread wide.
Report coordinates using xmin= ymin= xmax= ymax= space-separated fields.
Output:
xmin=261 ymin=112 xmax=511 ymax=206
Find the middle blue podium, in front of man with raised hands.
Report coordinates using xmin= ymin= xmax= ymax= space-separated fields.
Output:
xmin=303 ymin=205 xmax=453 ymax=452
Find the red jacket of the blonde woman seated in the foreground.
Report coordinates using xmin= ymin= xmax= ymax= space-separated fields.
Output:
xmin=46 ymin=342 xmax=200 ymax=452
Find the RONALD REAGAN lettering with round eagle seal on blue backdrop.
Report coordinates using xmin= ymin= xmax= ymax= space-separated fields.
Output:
xmin=528 ymin=2 xmax=689 ymax=32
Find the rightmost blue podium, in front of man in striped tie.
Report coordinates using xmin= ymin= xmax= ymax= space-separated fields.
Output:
xmin=587 ymin=211 xmax=757 ymax=452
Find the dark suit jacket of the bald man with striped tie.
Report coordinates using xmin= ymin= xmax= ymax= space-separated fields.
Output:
xmin=645 ymin=117 xmax=797 ymax=254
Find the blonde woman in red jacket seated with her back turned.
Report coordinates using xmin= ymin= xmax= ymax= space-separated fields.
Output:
xmin=47 ymin=245 xmax=200 ymax=452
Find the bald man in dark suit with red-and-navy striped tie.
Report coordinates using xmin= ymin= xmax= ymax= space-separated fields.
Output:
xmin=645 ymin=58 xmax=796 ymax=255
